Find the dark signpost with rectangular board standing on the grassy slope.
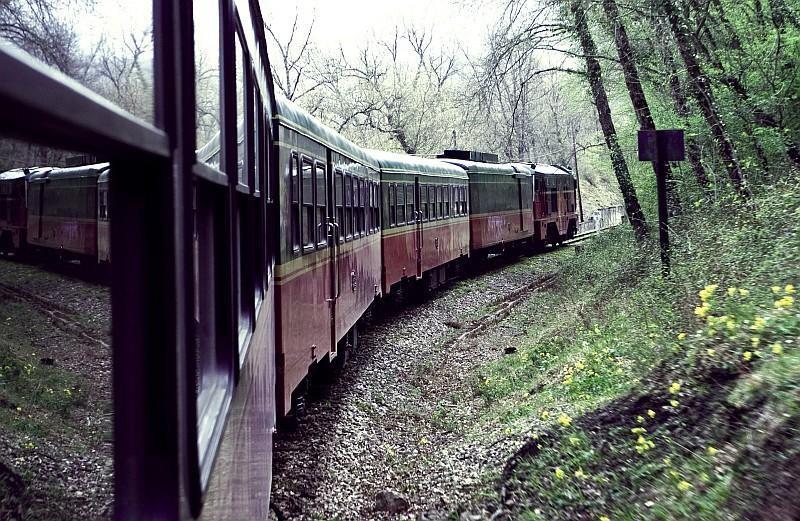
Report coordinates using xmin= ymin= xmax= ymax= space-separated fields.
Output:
xmin=638 ymin=130 xmax=686 ymax=278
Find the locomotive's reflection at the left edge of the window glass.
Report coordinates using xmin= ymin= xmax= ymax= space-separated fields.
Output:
xmin=0 ymin=167 xmax=52 ymax=252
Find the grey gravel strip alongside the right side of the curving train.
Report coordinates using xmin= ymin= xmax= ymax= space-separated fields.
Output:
xmin=272 ymin=250 xmax=555 ymax=519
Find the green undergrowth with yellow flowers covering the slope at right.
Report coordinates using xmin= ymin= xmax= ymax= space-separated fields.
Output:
xmin=474 ymin=177 xmax=800 ymax=520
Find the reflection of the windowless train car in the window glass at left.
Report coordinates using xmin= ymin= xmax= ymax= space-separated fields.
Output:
xmin=27 ymin=163 xmax=109 ymax=259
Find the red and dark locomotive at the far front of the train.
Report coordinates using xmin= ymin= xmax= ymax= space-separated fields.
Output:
xmin=531 ymin=163 xmax=578 ymax=244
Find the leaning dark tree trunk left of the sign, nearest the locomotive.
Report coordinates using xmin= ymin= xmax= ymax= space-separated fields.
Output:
xmin=570 ymin=0 xmax=647 ymax=239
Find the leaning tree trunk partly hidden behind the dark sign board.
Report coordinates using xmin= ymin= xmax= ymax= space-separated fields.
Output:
xmin=603 ymin=0 xmax=681 ymax=215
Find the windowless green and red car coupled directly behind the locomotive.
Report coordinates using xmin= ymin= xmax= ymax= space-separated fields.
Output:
xmin=442 ymin=151 xmax=533 ymax=254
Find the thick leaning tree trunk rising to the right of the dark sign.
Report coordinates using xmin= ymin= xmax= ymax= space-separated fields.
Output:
xmin=660 ymin=0 xmax=749 ymax=197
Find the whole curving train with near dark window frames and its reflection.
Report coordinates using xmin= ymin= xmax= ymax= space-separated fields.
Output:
xmin=0 ymin=0 xmax=578 ymax=519
